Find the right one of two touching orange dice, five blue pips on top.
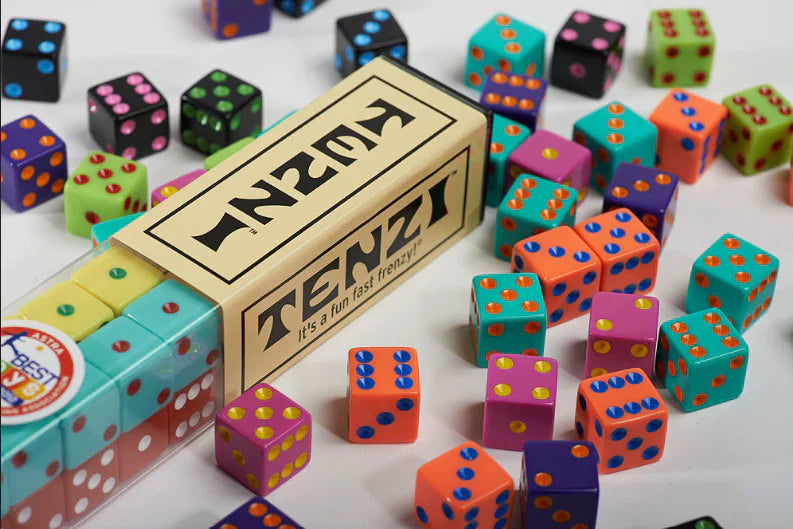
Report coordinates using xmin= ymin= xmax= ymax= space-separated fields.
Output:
xmin=574 ymin=208 xmax=661 ymax=294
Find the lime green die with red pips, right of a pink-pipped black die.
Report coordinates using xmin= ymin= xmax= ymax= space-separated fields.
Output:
xmin=644 ymin=9 xmax=716 ymax=87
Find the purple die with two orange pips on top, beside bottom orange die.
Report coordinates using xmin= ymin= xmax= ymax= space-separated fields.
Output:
xmin=518 ymin=441 xmax=600 ymax=529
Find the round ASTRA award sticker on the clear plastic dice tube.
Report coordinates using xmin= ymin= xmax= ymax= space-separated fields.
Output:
xmin=0 ymin=320 xmax=85 ymax=426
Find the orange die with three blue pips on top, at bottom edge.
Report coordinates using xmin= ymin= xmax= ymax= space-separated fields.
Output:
xmin=414 ymin=441 xmax=514 ymax=529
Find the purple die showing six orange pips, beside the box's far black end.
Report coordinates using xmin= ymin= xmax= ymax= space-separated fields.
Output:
xmin=479 ymin=72 xmax=548 ymax=132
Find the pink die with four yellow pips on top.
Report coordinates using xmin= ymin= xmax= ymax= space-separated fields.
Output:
xmin=482 ymin=354 xmax=559 ymax=450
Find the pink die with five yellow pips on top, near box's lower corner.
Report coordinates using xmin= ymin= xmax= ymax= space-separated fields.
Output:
xmin=215 ymin=383 xmax=311 ymax=496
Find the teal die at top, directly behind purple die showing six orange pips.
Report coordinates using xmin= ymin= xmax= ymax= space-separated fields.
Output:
xmin=465 ymin=13 xmax=545 ymax=90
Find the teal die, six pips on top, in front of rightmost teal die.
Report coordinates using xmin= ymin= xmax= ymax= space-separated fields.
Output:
xmin=655 ymin=309 xmax=749 ymax=411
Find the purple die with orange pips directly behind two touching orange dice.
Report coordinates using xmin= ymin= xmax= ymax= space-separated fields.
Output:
xmin=603 ymin=163 xmax=680 ymax=248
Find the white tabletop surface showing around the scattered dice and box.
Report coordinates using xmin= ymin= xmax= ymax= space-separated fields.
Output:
xmin=2 ymin=0 xmax=793 ymax=529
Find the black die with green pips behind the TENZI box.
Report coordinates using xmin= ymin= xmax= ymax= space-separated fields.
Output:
xmin=179 ymin=70 xmax=263 ymax=154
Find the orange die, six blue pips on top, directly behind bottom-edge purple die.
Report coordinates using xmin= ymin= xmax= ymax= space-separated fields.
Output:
xmin=575 ymin=368 xmax=667 ymax=474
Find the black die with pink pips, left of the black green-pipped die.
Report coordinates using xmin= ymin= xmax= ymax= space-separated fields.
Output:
xmin=88 ymin=72 xmax=170 ymax=160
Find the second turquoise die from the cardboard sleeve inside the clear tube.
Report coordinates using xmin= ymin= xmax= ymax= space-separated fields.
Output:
xmin=80 ymin=316 xmax=174 ymax=432
